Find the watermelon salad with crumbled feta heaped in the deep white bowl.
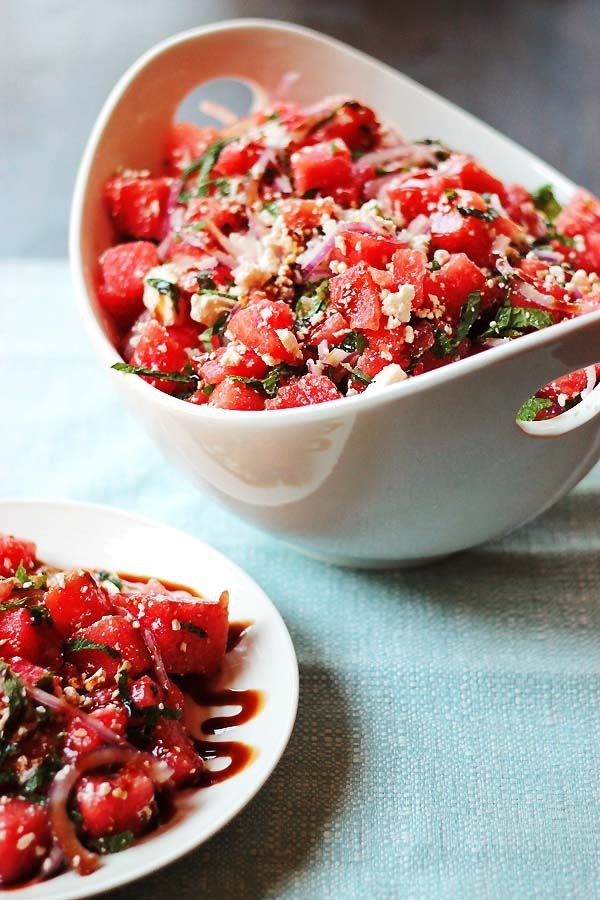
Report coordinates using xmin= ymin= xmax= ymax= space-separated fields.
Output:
xmin=97 ymin=97 xmax=600 ymax=419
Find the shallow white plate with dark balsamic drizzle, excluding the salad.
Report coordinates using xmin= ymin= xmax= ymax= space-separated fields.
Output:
xmin=0 ymin=500 xmax=298 ymax=900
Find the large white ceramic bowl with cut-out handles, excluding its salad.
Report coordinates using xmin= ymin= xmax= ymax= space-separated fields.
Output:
xmin=70 ymin=19 xmax=600 ymax=566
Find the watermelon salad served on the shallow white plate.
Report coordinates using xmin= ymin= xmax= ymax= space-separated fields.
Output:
xmin=0 ymin=535 xmax=228 ymax=886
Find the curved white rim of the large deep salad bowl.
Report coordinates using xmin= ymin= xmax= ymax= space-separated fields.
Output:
xmin=69 ymin=18 xmax=600 ymax=428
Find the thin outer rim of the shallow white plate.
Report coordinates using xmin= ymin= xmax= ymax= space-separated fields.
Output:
xmin=0 ymin=496 xmax=300 ymax=900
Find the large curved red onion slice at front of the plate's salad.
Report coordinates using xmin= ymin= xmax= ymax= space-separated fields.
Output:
xmin=48 ymin=747 xmax=173 ymax=875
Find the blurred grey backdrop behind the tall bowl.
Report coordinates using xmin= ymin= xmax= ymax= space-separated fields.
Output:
xmin=0 ymin=0 xmax=600 ymax=256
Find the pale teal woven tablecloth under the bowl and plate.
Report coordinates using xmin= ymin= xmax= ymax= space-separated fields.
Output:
xmin=0 ymin=261 xmax=600 ymax=900
